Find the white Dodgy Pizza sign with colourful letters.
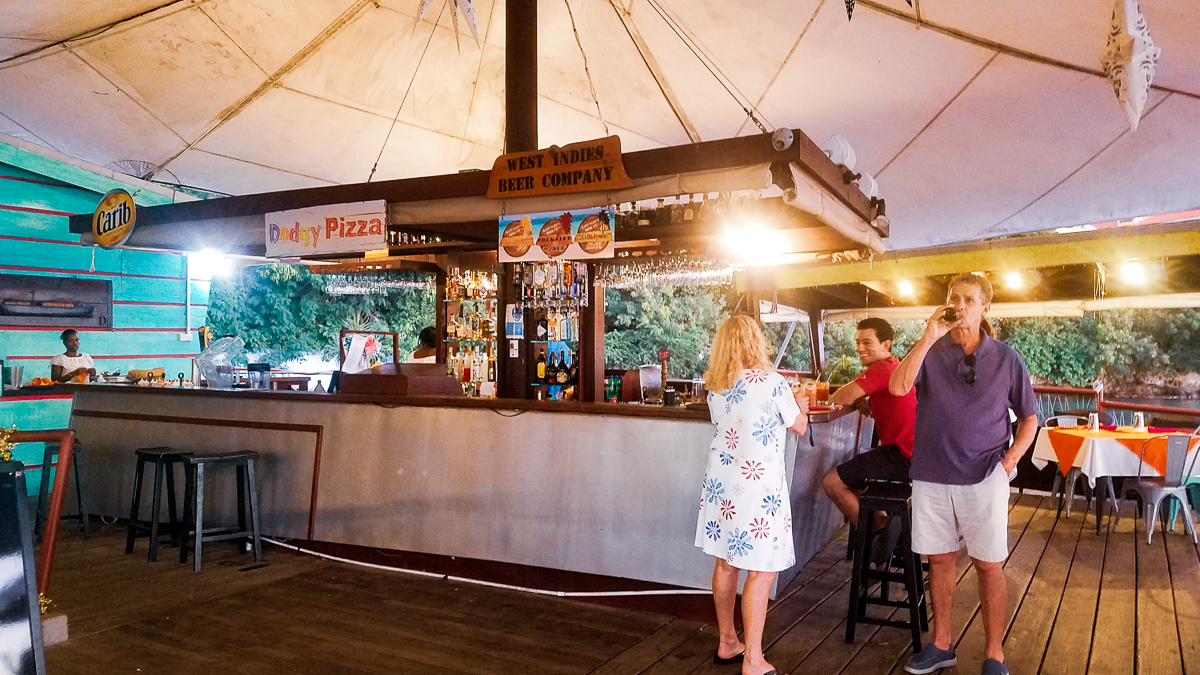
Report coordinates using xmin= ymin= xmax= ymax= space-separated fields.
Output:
xmin=265 ymin=199 xmax=388 ymax=258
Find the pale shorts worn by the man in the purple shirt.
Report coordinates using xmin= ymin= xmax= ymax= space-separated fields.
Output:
xmin=912 ymin=464 xmax=1009 ymax=562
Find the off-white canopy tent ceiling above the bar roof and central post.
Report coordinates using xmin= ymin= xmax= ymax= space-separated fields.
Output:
xmin=0 ymin=0 xmax=1200 ymax=249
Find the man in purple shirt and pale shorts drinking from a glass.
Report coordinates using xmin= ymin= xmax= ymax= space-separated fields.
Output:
xmin=888 ymin=274 xmax=1038 ymax=675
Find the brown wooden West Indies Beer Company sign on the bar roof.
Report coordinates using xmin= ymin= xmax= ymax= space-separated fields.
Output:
xmin=487 ymin=136 xmax=634 ymax=199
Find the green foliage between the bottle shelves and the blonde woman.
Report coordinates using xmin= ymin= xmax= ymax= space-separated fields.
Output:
xmin=605 ymin=287 xmax=731 ymax=377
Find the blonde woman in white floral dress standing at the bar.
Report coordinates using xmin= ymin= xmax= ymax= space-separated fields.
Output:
xmin=696 ymin=316 xmax=809 ymax=675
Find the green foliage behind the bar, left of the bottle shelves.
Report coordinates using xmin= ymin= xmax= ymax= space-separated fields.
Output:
xmin=209 ymin=264 xmax=434 ymax=364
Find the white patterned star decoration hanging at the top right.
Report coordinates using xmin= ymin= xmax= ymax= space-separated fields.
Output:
xmin=1100 ymin=0 xmax=1163 ymax=131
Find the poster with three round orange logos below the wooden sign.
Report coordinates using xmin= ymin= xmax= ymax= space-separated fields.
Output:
xmin=499 ymin=207 xmax=616 ymax=263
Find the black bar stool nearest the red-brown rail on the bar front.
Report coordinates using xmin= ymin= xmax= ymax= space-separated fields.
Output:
xmin=179 ymin=450 xmax=263 ymax=572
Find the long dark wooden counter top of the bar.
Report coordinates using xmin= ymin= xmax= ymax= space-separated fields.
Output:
xmin=68 ymin=383 xmax=853 ymax=424
